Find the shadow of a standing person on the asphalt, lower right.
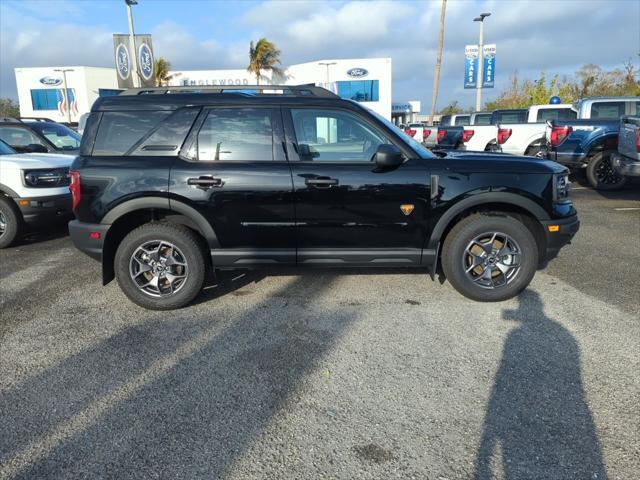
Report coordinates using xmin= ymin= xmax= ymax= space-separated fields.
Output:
xmin=474 ymin=290 xmax=606 ymax=480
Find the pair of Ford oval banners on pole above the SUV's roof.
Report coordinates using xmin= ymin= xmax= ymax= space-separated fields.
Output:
xmin=113 ymin=33 xmax=156 ymax=88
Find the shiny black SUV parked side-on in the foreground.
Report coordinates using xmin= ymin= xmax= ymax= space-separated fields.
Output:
xmin=69 ymin=86 xmax=579 ymax=309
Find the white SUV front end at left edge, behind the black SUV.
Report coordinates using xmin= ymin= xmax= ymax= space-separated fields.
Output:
xmin=0 ymin=140 xmax=74 ymax=248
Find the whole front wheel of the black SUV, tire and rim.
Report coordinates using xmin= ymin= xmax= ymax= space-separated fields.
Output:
xmin=442 ymin=213 xmax=538 ymax=302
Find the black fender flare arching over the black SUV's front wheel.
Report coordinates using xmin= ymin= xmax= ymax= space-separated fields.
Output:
xmin=427 ymin=192 xmax=549 ymax=249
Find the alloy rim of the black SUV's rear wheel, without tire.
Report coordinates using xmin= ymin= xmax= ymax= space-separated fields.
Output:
xmin=129 ymin=240 xmax=189 ymax=297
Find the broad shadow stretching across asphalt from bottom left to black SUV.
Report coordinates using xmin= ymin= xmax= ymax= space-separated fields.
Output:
xmin=0 ymin=274 xmax=355 ymax=479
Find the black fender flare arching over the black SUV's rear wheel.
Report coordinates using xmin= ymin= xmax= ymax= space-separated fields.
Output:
xmin=100 ymin=197 xmax=220 ymax=248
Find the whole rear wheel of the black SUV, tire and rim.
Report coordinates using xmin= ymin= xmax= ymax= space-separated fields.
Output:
xmin=115 ymin=223 xmax=208 ymax=310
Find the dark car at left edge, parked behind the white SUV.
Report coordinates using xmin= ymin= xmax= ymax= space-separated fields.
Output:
xmin=0 ymin=117 xmax=80 ymax=155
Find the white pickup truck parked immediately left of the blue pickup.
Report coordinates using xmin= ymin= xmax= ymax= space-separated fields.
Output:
xmin=496 ymin=103 xmax=577 ymax=156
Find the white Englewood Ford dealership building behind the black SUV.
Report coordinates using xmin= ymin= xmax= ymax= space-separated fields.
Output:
xmin=15 ymin=58 xmax=408 ymax=122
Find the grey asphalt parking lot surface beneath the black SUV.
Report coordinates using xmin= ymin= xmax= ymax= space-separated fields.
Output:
xmin=0 ymin=182 xmax=640 ymax=479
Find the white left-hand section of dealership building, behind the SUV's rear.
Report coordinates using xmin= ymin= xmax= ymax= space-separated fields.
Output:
xmin=15 ymin=66 xmax=118 ymax=122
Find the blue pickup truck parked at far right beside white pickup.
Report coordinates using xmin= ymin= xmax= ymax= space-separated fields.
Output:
xmin=545 ymin=97 xmax=640 ymax=190
